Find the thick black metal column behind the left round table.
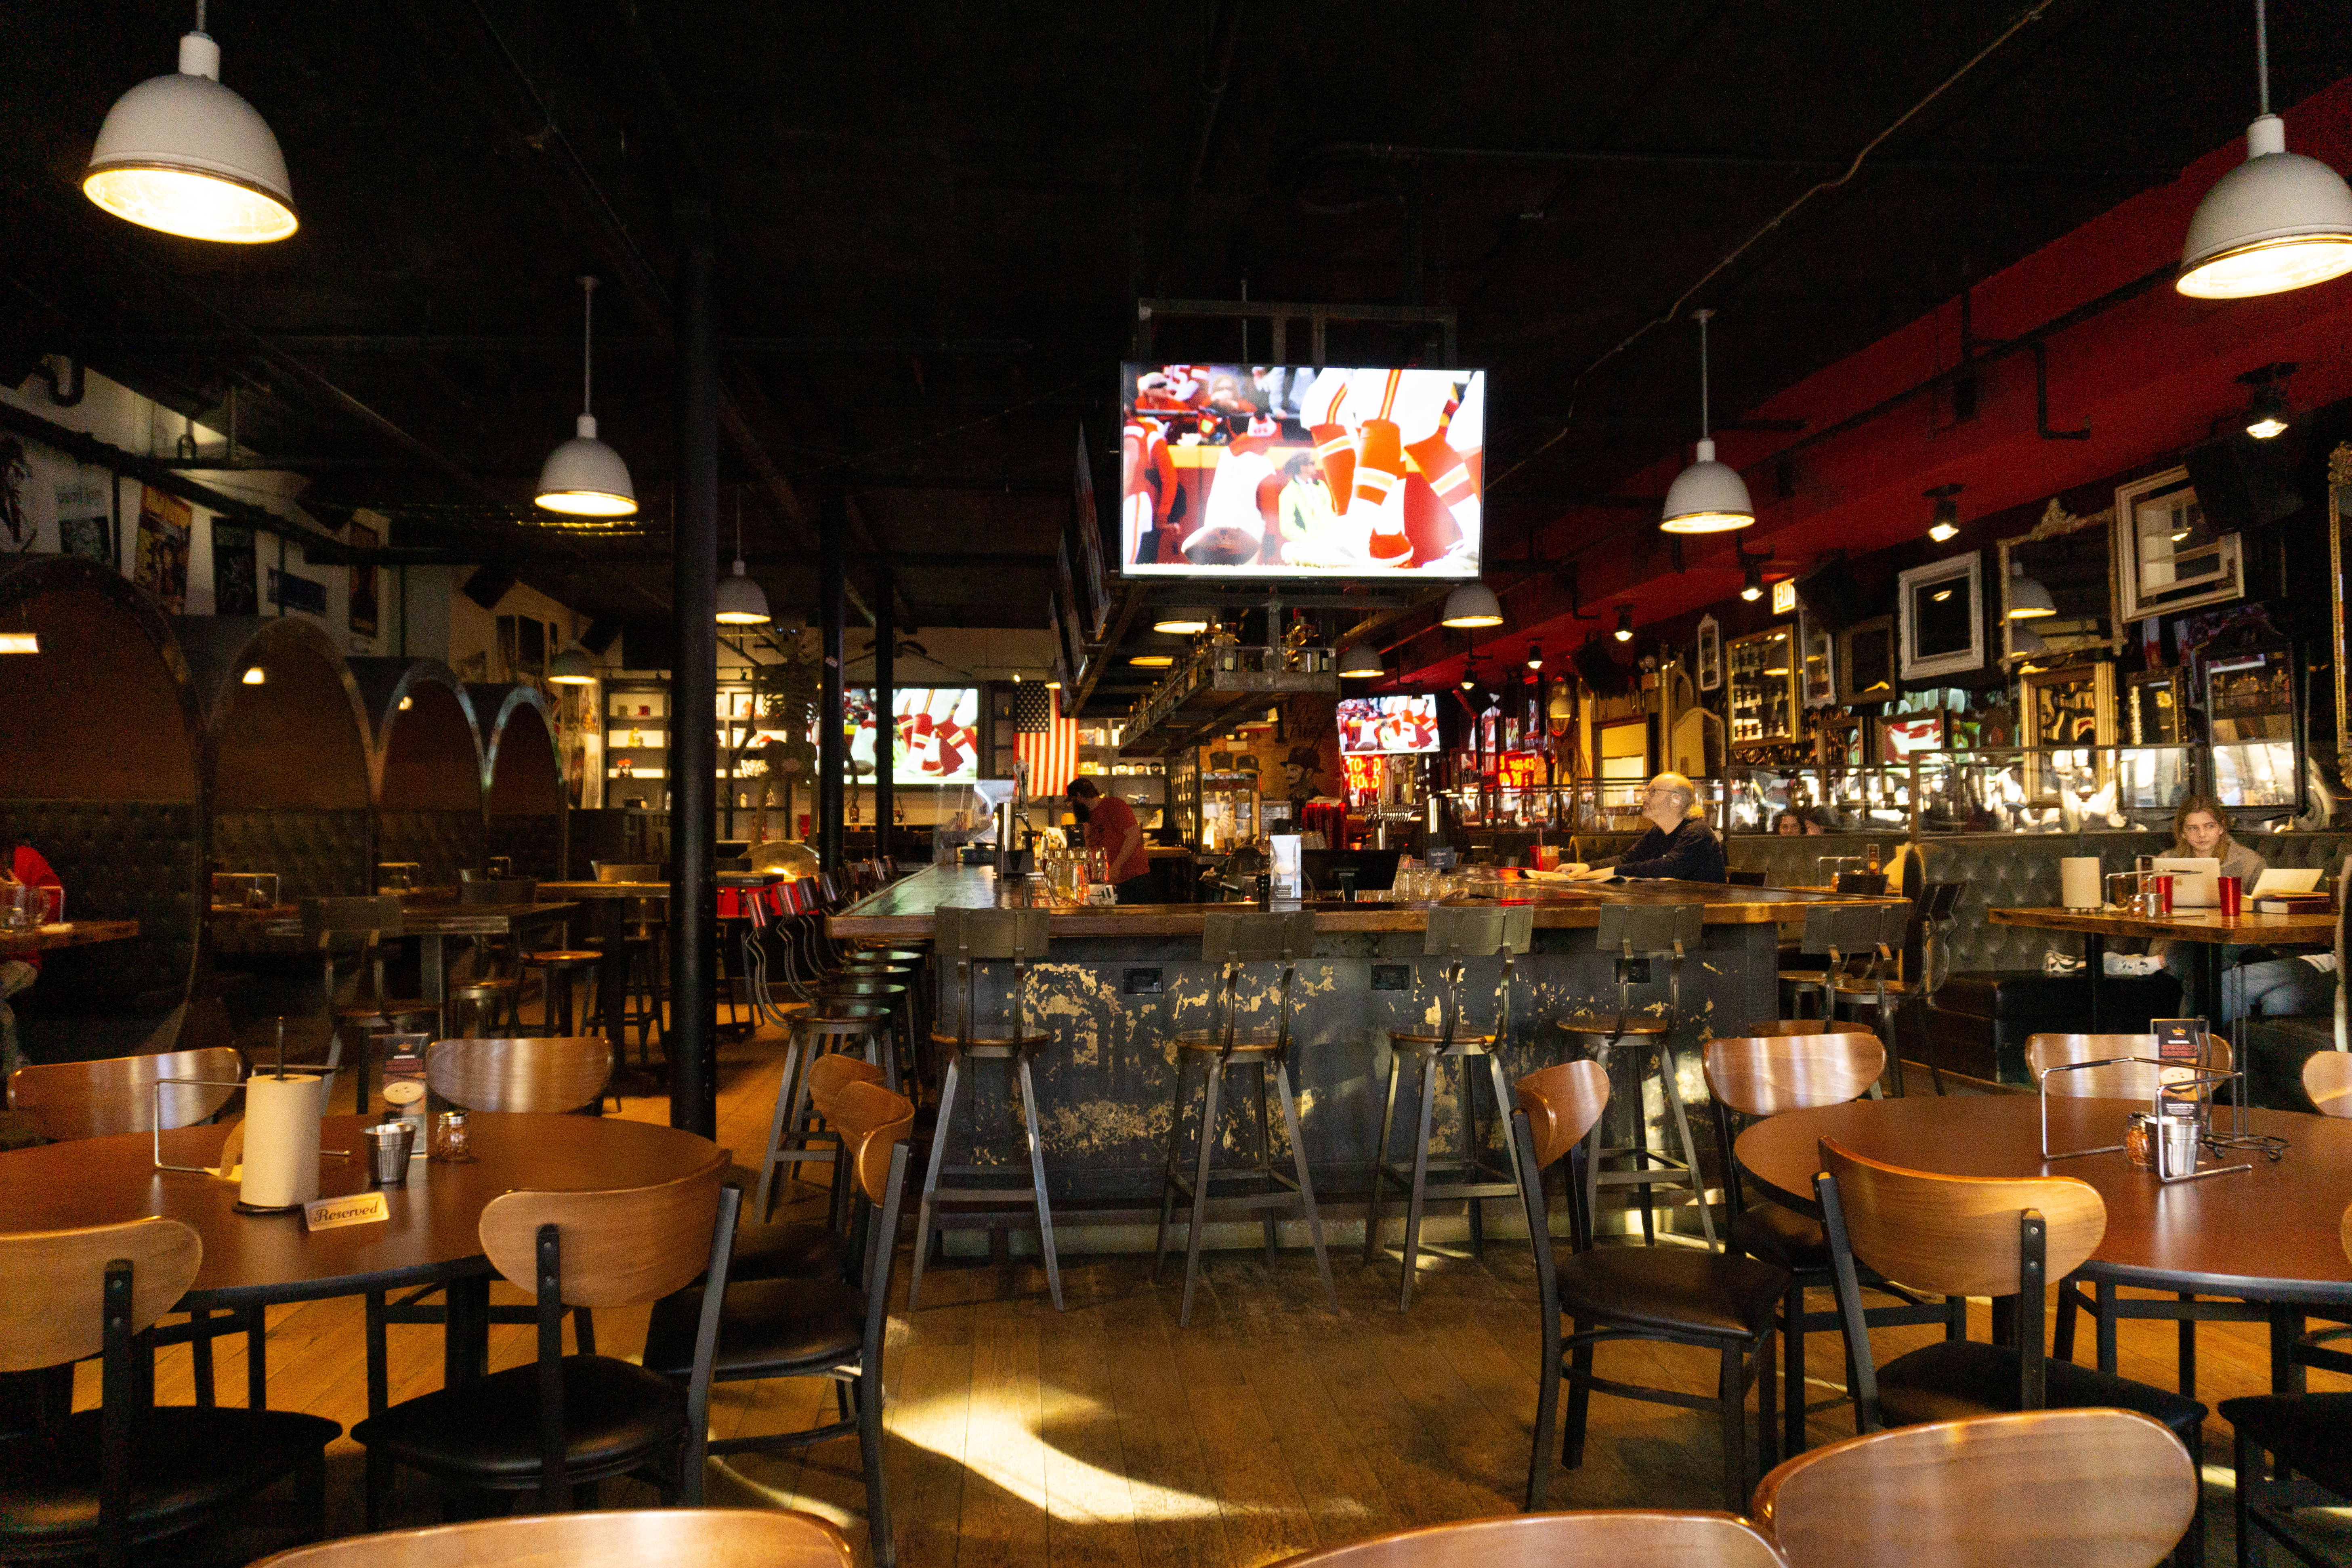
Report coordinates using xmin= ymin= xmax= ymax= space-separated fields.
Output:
xmin=672 ymin=209 xmax=720 ymax=1138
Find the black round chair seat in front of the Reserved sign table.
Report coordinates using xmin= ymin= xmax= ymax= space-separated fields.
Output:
xmin=351 ymin=1354 xmax=699 ymax=1486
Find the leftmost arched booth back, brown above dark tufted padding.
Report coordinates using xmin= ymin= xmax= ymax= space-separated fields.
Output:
xmin=0 ymin=555 xmax=207 ymax=1060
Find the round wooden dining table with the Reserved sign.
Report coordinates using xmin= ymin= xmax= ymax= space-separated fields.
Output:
xmin=0 ymin=1112 xmax=727 ymax=1408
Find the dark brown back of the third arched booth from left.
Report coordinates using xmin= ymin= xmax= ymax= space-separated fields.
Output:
xmin=351 ymin=658 xmax=487 ymax=889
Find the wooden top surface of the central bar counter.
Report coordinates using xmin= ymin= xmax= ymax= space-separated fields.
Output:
xmin=825 ymin=865 xmax=1891 ymax=938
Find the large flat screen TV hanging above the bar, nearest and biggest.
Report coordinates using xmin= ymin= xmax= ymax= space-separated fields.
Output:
xmin=1119 ymin=364 xmax=1487 ymax=581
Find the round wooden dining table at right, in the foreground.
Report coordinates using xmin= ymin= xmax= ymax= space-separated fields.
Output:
xmin=1733 ymin=1096 xmax=2352 ymax=1392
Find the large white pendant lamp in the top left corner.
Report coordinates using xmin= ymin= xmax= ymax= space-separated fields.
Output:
xmin=82 ymin=0 xmax=301 ymax=244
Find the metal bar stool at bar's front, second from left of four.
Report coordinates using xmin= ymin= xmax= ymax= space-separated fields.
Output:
xmin=1153 ymin=910 xmax=1338 ymax=1328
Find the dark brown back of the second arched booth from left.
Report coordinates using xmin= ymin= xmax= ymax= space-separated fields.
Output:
xmin=176 ymin=616 xmax=376 ymax=903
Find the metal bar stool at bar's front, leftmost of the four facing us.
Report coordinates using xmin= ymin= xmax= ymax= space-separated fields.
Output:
xmin=905 ymin=910 xmax=1061 ymax=1312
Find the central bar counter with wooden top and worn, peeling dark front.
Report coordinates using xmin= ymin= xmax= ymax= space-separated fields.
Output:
xmin=828 ymin=867 xmax=1884 ymax=1246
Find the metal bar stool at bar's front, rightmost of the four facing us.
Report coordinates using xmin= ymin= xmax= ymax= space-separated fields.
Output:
xmin=1557 ymin=903 xmax=1715 ymax=1251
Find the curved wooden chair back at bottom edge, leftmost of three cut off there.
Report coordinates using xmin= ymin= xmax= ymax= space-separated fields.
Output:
xmin=254 ymin=1509 xmax=854 ymax=1568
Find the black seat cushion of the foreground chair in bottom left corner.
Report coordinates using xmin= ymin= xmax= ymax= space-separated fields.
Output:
xmin=0 ymin=1406 xmax=343 ymax=1549
